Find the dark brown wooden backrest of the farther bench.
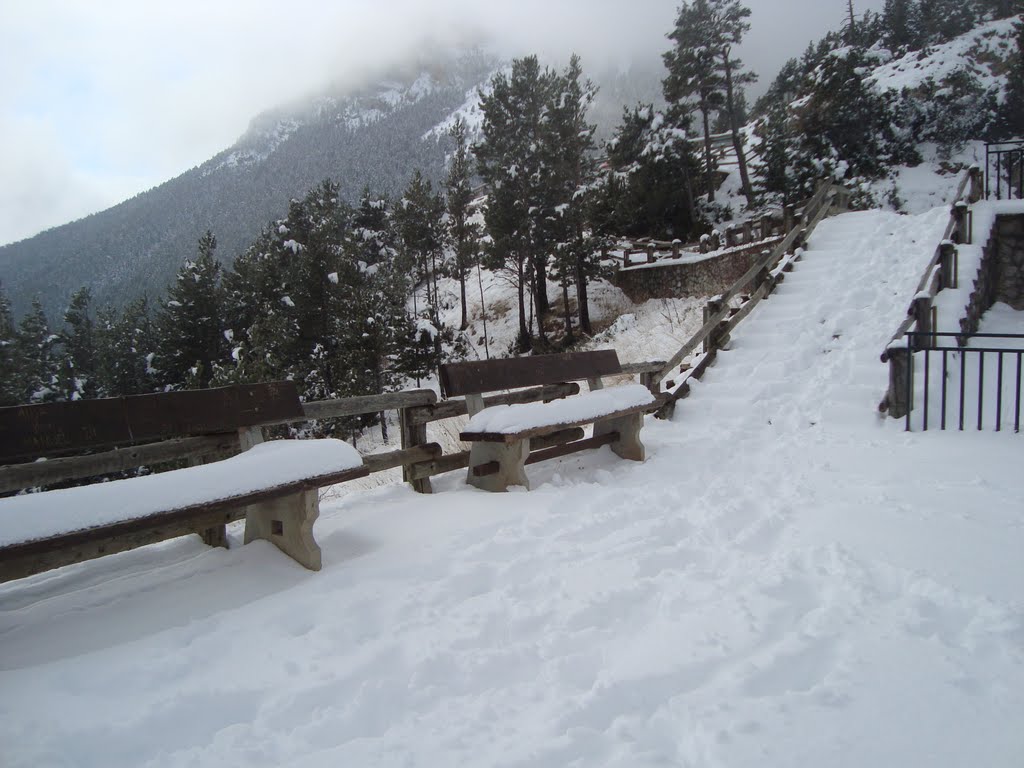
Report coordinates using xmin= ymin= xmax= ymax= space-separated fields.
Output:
xmin=440 ymin=349 xmax=623 ymax=397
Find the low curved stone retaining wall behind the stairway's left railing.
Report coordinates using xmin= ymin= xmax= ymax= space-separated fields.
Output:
xmin=614 ymin=249 xmax=764 ymax=303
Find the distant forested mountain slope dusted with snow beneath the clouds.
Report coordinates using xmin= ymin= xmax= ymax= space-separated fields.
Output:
xmin=0 ymin=53 xmax=497 ymax=319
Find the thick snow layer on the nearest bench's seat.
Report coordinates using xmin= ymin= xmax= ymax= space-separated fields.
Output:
xmin=0 ymin=439 xmax=362 ymax=546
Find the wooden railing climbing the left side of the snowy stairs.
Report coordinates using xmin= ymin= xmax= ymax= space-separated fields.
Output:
xmin=654 ymin=180 xmax=850 ymax=418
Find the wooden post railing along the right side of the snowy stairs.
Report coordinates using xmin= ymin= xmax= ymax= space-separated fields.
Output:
xmin=879 ymin=166 xmax=985 ymax=419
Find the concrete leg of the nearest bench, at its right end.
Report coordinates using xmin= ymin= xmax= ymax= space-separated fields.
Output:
xmin=245 ymin=489 xmax=323 ymax=570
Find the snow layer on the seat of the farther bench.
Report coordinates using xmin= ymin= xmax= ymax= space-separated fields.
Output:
xmin=464 ymin=384 xmax=654 ymax=434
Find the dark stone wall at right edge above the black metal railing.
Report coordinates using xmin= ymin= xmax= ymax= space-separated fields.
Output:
xmin=961 ymin=214 xmax=1024 ymax=335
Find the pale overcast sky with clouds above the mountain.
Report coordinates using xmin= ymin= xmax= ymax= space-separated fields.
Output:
xmin=0 ymin=0 xmax=883 ymax=244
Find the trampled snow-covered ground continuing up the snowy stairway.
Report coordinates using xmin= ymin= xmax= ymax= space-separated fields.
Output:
xmin=0 ymin=210 xmax=1024 ymax=768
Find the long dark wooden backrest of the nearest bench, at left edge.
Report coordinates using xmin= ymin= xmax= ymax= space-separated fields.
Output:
xmin=0 ymin=381 xmax=302 ymax=464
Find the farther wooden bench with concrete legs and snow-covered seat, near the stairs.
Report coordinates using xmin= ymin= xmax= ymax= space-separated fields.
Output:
xmin=440 ymin=349 xmax=659 ymax=490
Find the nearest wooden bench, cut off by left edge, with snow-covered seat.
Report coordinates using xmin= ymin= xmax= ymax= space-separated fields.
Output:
xmin=0 ymin=382 xmax=369 ymax=582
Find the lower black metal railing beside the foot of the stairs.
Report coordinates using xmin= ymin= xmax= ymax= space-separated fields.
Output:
xmin=906 ymin=331 xmax=1024 ymax=433
